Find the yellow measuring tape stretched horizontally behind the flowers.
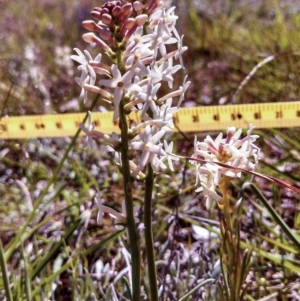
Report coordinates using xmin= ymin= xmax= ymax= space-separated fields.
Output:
xmin=0 ymin=101 xmax=300 ymax=139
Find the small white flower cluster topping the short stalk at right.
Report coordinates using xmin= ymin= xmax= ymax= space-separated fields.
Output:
xmin=192 ymin=125 xmax=259 ymax=207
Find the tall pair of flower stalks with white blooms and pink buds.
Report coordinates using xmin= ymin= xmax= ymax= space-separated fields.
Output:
xmin=72 ymin=0 xmax=190 ymax=301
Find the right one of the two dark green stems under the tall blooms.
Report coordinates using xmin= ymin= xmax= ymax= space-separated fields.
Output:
xmin=144 ymin=164 xmax=158 ymax=301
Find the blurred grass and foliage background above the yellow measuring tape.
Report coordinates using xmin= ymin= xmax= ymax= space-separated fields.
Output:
xmin=0 ymin=0 xmax=300 ymax=115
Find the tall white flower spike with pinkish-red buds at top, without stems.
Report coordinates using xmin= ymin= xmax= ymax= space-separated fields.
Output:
xmin=72 ymin=0 xmax=190 ymax=185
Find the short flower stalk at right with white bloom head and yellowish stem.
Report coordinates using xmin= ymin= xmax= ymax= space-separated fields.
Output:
xmin=191 ymin=125 xmax=259 ymax=301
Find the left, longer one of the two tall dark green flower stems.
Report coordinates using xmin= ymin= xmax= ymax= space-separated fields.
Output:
xmin=119 ymin=99 xmax=141 ymax=301
